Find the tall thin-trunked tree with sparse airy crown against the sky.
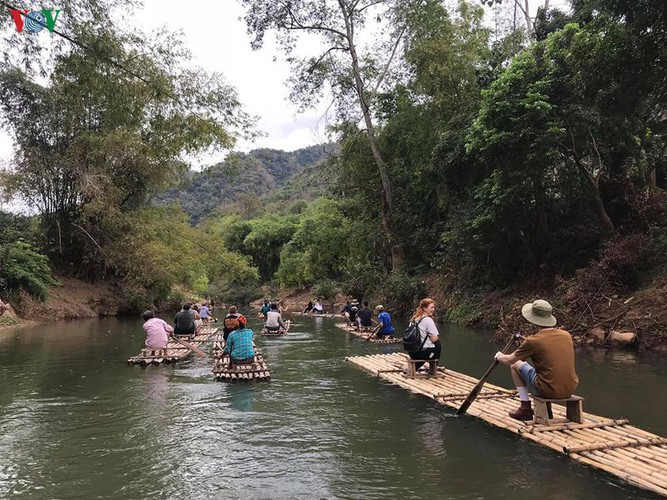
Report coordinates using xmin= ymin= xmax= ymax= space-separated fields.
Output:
xmin=241 ymin=0 xmax=416 ymax=269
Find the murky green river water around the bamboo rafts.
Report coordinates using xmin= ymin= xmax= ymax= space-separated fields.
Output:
xmin=0 ymin=317 xmax=667 ymax=499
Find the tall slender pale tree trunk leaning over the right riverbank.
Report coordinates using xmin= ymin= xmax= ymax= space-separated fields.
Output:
xmin=338 ymin=0 xmax=403 ymax=271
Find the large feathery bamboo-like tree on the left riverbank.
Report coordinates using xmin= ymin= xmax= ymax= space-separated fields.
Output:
xmin=0 ymin=29 xmax=251 ymax=275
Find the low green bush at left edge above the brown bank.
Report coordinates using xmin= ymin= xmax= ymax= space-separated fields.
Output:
xmin=0 ymin=241 xmax=58 ymax=301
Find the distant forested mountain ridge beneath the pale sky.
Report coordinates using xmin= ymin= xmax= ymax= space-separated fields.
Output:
xmin=156 ymin=144 xmax=337 ymax=224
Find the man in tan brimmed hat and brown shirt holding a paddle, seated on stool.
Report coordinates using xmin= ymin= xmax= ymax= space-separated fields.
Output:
xmin=494 ymin=299 xmax=579 ymax=420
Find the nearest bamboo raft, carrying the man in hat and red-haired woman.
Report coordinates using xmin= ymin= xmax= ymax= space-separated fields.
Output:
xmin=346 ymin=353 xmax=667 ymax=496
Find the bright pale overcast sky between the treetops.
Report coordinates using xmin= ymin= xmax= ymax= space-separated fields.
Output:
xmin=0 ymin=0 xmax=566 ymax=170
